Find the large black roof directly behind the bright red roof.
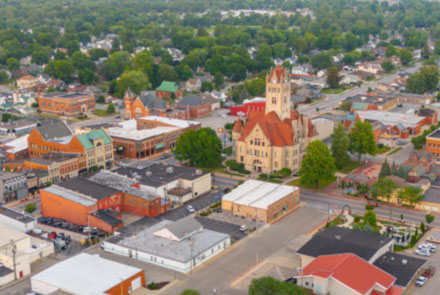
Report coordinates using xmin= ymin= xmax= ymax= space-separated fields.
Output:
xmin=297 ymin=226 xmax=393 ymax=261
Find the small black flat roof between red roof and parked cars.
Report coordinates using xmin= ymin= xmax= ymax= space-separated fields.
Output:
xmin=373 ymin=252 xmax=426 ymax=287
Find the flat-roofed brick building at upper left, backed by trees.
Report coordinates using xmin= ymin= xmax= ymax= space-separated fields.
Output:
xmin=38 ymin=92 xmax=95 ymax=116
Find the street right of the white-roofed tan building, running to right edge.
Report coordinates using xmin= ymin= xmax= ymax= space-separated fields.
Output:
xmin=301 ymin=192 xmax=440 ymax=227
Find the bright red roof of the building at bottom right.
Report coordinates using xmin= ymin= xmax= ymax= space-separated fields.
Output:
xmin=302 ymin=254 xmax=401 ymax=295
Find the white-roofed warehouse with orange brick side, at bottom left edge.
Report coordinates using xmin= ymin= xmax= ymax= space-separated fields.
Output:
xmin=31 ymin=253 xmax=145 ymax=295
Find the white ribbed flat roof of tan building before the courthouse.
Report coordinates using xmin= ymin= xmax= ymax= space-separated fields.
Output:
xmin=223 ymin=180 xmax=298 ymax=209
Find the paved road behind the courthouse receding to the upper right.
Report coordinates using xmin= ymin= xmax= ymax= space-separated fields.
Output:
xmin=299 ymin=63 xmax=421 ymax=116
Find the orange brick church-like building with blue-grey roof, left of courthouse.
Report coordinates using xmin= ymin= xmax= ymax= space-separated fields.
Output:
xmin=124 ymin=89 xmax=188 ymax=119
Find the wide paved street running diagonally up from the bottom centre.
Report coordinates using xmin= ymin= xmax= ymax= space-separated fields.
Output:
xmin=164 ymin=208 xmax=326 ymax=295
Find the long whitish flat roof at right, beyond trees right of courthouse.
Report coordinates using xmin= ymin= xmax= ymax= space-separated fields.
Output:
xmin=356 ymin=111 xmax=425 ymax=128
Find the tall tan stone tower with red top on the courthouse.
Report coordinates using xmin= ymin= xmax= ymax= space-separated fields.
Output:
xmin=266 ymin=65 xmax=291 ymax=121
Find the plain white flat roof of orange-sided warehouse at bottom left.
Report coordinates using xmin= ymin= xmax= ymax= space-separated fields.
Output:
xmin=31 ymin=253 xmax=142 ymax=295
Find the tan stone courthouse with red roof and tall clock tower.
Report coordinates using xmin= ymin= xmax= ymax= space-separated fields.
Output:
xmin=232 ymin=65 xmax=317 ymax=173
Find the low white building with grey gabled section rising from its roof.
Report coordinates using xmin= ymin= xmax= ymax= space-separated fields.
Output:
xmin=103 ymin=216 xmax=231 ymax=273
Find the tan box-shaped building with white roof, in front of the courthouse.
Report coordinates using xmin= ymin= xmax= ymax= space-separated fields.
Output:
xmin=222 ymin=180 xmax=300 ymax=223
